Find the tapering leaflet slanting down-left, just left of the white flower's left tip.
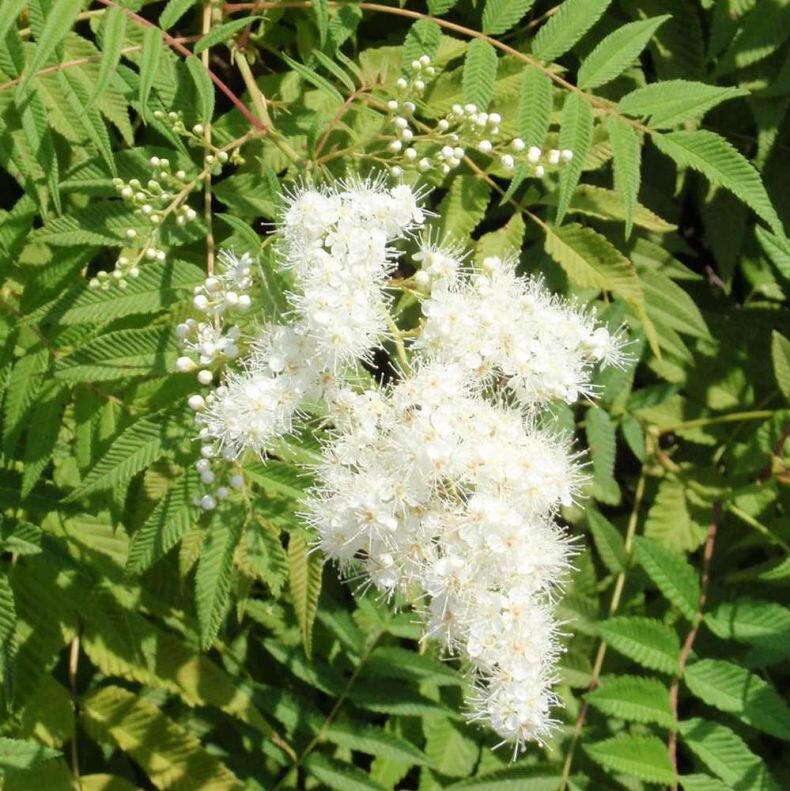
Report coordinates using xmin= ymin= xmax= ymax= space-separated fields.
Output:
xmin=66 ymin=415 xmax=173 ymax=502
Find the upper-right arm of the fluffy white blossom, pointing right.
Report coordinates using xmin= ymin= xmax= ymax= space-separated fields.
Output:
xmin=417 ymin=254 xmax=621 ymax=407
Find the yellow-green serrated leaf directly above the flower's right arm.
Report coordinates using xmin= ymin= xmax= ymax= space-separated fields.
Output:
xmin=544 ymin=223 xmax=644 ymax=306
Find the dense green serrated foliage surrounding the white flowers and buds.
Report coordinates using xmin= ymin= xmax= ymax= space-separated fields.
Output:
xmin=0 ymin=0 xmax=790 ymax=791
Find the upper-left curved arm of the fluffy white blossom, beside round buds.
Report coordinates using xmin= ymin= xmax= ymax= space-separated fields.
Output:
xmin=192 ymin=180 xmax=423 ymax=458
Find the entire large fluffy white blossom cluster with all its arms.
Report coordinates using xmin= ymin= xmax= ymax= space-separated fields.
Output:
xmin=178 ymin=181 xmax=621 ymax=751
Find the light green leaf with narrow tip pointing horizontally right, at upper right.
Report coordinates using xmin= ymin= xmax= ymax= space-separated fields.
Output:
xmin=617 ymin=80 xmax=748 ymax=129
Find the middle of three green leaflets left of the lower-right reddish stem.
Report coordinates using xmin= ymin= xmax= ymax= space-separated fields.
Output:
xmin=585 ymin=676 xmax=675 ymax=728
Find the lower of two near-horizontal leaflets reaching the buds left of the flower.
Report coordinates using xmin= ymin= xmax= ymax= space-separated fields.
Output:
xmin=55 ymin=327 xmax=178 ymax=382
